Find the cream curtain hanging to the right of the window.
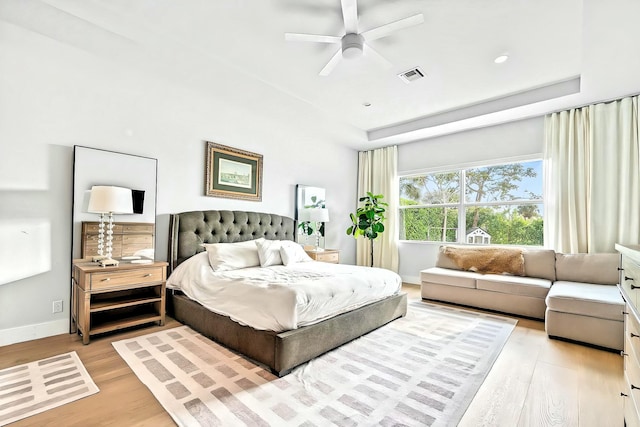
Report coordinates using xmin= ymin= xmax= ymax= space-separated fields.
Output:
xmin=544 ymin=96 xmax=640 ymax=253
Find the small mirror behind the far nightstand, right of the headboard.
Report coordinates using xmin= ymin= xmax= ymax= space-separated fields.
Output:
xmin=295 ymin=184 xmax=329 ymax=250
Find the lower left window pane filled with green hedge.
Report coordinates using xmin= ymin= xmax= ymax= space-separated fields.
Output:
xmin=400 ymin=207 xmax=458 ymax=242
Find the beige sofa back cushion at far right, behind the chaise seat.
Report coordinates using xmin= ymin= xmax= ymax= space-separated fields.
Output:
xmin=556 ymin=253 xmax=619 ymax=285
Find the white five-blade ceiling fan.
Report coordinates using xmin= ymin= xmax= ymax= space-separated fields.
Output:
xmin=284 ymin=0 xmax=424 ymax=76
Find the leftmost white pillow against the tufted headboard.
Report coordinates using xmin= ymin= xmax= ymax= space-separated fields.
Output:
xmin=202 ymin=237 xmax=264 ymax=271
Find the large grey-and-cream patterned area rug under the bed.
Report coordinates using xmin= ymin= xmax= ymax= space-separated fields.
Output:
xmin=113 ymin=302 xmax=516 ymax=426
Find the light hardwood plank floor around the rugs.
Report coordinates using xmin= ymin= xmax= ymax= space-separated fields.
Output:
xmin=0 ymin=285 xmax=623 ymax=427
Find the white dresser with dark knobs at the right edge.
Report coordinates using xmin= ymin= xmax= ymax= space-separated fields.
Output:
xmin=616 ymin=245 xmax=640 ymax=427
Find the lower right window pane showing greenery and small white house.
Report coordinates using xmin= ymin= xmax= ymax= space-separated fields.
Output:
xmin=461 ymin=204 xmax=543 ymax=246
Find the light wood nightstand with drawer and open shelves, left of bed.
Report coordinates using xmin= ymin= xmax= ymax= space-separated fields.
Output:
xmin=71 ymin=259 xmax=167 ymax=344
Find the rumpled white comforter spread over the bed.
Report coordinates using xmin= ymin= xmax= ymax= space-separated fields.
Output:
xmin=167 ymin=252 xmax=402 ymax=332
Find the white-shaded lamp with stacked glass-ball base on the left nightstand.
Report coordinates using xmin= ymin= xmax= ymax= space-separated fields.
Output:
xmin=87 ymin=185 xmax=133 ymax=267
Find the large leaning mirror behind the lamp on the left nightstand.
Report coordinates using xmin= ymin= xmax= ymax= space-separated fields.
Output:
xmin=72 ymin=145 xmax=158 ymax=259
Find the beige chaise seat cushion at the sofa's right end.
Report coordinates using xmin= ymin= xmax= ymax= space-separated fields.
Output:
xmin=546 ymin=281 xmax=624 ymax=321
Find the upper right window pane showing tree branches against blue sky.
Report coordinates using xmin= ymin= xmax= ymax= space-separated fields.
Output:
xmin=465 ymin=160 xmax=542 ymax=206
